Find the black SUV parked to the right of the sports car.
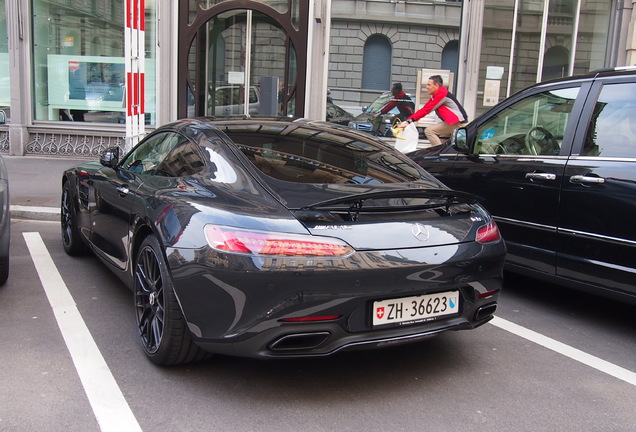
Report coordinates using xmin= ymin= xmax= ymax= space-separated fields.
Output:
xmin=409 ymin=68 xmax=636 ymax=303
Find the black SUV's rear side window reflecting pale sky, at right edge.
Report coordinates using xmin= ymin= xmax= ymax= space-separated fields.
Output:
xmin=582 ymin=83 xmax=636 ymax=158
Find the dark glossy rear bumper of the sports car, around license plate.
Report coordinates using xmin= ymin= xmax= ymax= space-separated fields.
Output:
xmin=168 ymin=243 xmax=504 ymax=358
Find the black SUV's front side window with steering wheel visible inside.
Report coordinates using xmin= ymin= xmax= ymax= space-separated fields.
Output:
xmin=474 ymin=87 xmax=579 ymax=155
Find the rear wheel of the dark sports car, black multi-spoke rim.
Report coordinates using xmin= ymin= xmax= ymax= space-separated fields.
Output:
xmin=133 ymin=235 xmax=209 ymax=366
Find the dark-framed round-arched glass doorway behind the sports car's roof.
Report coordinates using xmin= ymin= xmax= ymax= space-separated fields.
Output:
xmin=177 ymin=0 xmax=309 ymax=118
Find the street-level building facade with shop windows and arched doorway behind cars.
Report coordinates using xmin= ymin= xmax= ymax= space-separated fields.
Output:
xmin=0 ymin=0 xmax=636 ymax=157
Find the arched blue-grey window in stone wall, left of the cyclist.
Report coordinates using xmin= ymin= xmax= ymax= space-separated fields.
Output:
xmin=362 ymin=34 xmax=391 ymax=90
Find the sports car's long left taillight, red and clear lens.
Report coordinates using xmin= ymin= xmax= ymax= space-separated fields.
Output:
xmin=205 ymin=225 xmax=353 ymax=257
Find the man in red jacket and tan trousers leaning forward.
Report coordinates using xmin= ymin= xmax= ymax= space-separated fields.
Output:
xmin=400 ymin=75 xmax=468 ymax=146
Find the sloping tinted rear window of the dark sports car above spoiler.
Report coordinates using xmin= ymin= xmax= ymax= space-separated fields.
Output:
xmin=222 ymin=125 xmax=428 ymax=184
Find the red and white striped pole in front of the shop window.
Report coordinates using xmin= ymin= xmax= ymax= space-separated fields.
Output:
xmin=124 ymin=0 xmax=146 ymax=151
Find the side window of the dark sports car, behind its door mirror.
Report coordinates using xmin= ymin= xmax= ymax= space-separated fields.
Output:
xmin=121 ymin=132 xmax=185 ymax=174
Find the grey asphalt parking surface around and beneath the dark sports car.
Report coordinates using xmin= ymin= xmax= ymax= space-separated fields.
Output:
xmin=0 ymin=219 xmax=636 ymax=432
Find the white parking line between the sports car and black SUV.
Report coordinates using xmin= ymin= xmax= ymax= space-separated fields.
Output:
xmin=490 ymin=317 xmax=636 ymax=385
